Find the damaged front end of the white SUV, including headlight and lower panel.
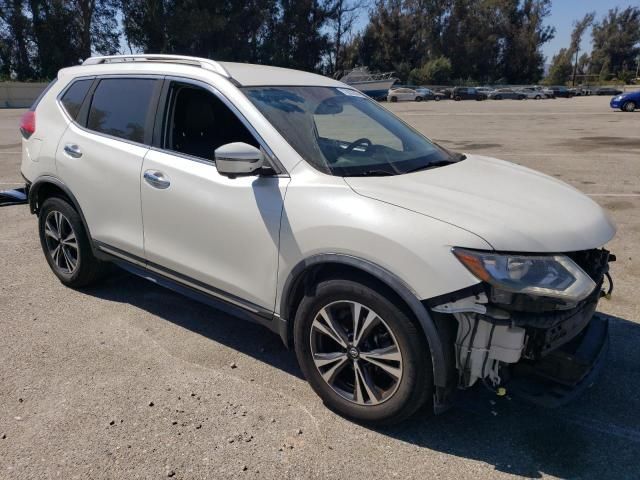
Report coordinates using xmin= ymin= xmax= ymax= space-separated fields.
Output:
xmin=427 ymin=249 xmax=615 ymax=407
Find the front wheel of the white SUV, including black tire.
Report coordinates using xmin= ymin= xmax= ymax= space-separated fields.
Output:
xmin=294 ymin=280 xmax=433 ymax=425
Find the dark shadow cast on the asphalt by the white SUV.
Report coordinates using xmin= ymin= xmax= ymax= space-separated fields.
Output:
xmin=84 ymin=270 xmax=640 ymax=479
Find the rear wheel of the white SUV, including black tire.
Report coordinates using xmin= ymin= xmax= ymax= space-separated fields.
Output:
xmin=38 ymin=197 xmax=107 ymax=288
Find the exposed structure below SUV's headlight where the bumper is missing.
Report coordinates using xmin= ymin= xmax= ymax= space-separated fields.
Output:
xmin=431 ymin=249 xmax=615 ymax=394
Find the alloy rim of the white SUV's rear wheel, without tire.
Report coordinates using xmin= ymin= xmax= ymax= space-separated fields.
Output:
xmin=44 ymin=210 xmax=80 ymax=275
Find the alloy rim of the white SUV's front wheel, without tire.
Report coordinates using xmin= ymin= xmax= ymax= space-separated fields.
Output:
xmin=309 ymin=300 xmax=403 ymax=405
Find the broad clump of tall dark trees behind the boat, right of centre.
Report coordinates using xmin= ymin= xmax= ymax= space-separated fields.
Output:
xmin=358 ymin=0 xmax=554 ymax=83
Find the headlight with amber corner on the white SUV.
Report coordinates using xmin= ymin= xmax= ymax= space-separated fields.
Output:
xmin=453 ymin=248 xmax=596 ymax=302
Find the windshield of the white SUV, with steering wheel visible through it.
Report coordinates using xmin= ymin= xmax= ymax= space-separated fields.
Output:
xmin=243 ymin=87 xmax=462 ymax=177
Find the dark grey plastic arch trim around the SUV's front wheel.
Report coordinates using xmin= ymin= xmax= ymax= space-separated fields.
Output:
xmin=279 ymin=253 xmax=449 ymax=387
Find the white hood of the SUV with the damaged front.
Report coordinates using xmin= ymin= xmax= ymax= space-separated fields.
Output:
xmin=345 ymin=155 xmax=616 ymax=253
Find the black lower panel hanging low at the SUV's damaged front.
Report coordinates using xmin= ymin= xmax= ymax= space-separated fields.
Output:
xmin=509 ymin=315 xmax=609 ymax=408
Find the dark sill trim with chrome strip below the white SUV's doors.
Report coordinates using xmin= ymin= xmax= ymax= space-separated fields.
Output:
xmin=94 ymin=241 xmax=279 ymax=333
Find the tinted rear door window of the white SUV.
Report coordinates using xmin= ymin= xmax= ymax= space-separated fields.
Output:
xmin=87 ymin=78 xmax=159 ymax=143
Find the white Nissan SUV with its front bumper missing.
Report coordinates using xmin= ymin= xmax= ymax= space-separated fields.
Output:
xmin=21 ymin=55 xmax=615 ymax=423
